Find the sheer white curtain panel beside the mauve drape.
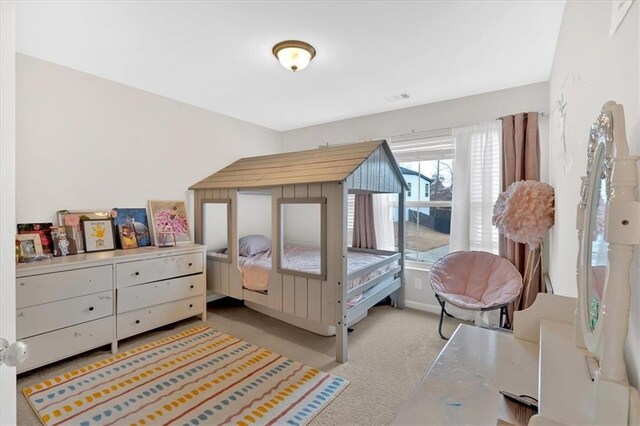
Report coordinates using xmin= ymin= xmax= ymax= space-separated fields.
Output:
xmin=451 ymin=121 xmax=501 ymax=254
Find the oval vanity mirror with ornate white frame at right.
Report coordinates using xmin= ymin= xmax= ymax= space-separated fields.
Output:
xmin=576 ymin=102 xmax=640 ymax=383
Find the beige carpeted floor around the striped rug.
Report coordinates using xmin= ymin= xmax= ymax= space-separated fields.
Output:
xmin=18 ymin=300 xmax=458 ymax=425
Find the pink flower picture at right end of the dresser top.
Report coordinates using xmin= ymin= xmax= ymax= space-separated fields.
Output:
xmin=149 ymin=200 xmax=192 ymax=247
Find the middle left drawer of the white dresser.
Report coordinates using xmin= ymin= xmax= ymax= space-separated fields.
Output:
xmin=16 ymin=290 xmax=113 ymax=339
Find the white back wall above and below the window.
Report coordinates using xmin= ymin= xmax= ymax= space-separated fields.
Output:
xmin=283 ymin=83 xmax=548 ymax=312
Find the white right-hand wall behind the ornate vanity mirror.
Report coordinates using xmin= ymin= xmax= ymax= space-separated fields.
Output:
xmin=549 ymin=2 xmax=640 ymax=385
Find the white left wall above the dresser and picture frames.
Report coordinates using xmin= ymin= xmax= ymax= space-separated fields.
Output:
xmin=16 ymin=55 xmax=281 ymax=222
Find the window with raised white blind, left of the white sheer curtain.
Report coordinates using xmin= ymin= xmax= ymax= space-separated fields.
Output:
xmin=391 ymin=130 xmax=454 ymax=264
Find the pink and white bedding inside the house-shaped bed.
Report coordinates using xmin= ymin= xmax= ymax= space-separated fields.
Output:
xmin=209 ymin=243 xmax=398 ymax=307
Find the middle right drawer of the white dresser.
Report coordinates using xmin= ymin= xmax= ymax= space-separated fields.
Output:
xmin=116 ymin=274 xmax=205 ymax=314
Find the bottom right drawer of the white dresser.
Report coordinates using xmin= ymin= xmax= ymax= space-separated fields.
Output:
xmin=117 ymin=296 xmax=204 ymax=339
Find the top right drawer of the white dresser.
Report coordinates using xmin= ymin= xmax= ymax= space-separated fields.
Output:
xmin=116 ymin=253 xmax=202 ymax=287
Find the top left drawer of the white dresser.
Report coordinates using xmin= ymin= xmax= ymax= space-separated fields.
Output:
xmin=16 ymin=265 xmax=113 ymax=308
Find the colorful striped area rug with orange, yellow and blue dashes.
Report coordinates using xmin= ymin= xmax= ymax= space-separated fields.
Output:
xmin=23 ymin=326 xmax=349 ymax=425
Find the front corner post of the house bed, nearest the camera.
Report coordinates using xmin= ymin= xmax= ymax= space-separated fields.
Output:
xmin=336 ymin=181 xmax=349 ymax=362
